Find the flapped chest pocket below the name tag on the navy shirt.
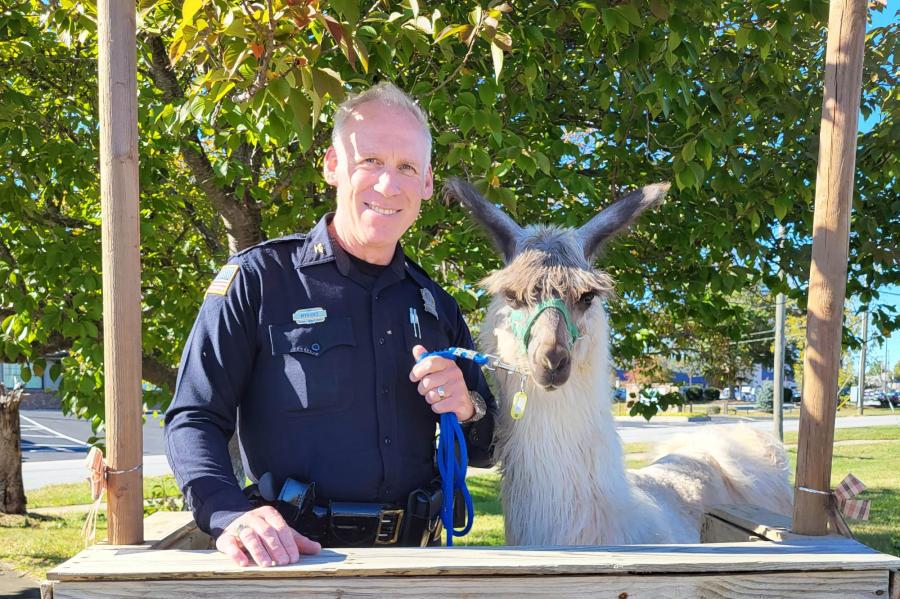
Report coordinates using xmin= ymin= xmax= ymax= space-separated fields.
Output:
xmin=269 ymin=317 xmax=356 ymax=414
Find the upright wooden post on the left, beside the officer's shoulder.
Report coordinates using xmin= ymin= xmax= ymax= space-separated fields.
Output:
xmin=97 ymin=0 xmax=144 ymax=545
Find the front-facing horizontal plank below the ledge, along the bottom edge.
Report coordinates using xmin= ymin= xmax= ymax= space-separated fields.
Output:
xmin=54 ymin=570 xmax=888 ymax=599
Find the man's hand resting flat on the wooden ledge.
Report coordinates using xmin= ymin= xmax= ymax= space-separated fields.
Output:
xmin=216 ymin=505 xmax=322 ymax=567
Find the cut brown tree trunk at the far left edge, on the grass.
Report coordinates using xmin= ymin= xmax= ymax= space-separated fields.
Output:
xmin=0 ymin=383 xmax=26 ymax=514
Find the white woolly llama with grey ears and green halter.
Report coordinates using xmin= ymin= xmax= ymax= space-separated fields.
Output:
xmin=445 ymin=179 xmax=791 ymax=545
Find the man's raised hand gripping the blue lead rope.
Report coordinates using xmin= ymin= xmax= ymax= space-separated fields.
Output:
xmin=409 ymin=345 xmax=475 ymax=422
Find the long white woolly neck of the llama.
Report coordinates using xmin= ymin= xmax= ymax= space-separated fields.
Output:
xmin=482 ymin=302 xmax=633 ymax=544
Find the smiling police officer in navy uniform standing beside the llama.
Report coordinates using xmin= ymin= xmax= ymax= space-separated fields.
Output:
xmin=166 ymin=83 xmax=495 ymax=566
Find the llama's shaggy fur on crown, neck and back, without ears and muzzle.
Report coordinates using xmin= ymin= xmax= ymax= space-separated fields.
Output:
xmin=480 ymin=226 xmax=791 ymax=545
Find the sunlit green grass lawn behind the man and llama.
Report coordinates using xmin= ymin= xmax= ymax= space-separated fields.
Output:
xmin=0 ymin=426 xmax=900 ymax=578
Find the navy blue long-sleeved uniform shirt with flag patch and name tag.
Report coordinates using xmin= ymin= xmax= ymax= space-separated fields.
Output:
xmin=165 ymin=215 xmax=496 ymax=536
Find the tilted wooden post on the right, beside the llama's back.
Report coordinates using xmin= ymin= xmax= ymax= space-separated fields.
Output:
xmin=793 ymin=0 xmax=866 ymax=535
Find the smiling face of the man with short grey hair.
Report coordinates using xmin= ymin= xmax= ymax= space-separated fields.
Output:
xmin=324 ymin=102 xmax=434 ymax=255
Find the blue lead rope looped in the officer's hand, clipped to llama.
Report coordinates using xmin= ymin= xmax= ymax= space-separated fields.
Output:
xmin=418 ymin=347 xmax=490 ymax=547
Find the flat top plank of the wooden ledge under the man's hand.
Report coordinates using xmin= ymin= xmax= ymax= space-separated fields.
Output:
xmin=47 ymin=537 xmax=900 ymax=581
